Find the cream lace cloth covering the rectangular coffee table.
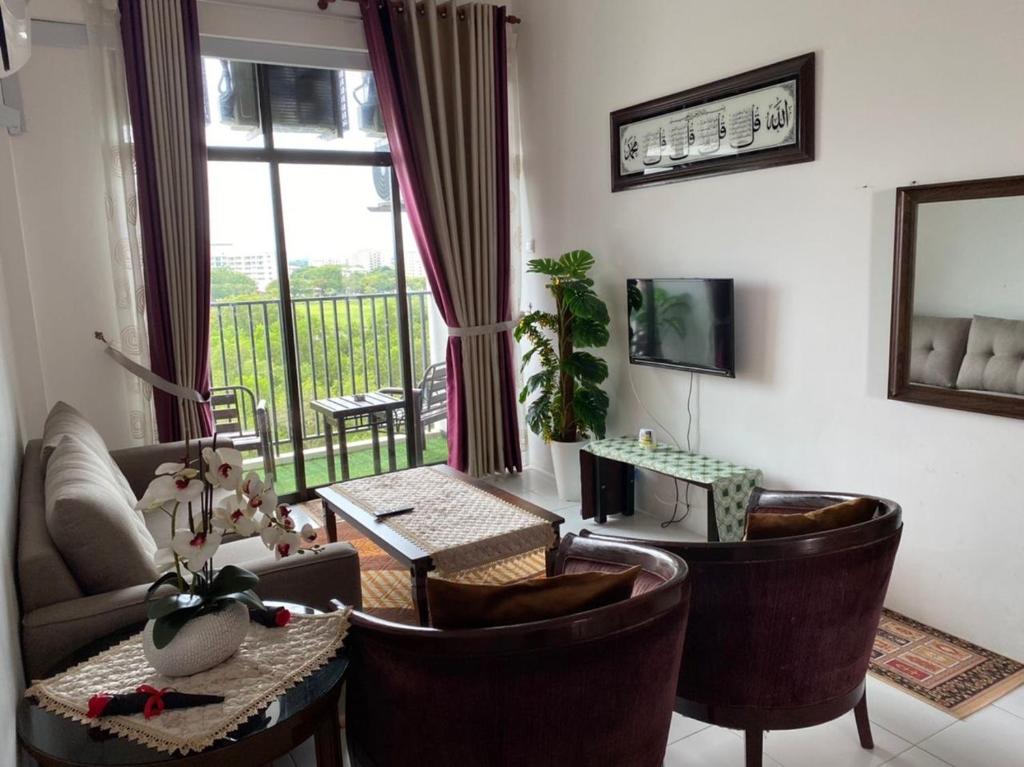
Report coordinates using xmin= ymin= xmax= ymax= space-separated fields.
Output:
xmin=331 ymin=460 xmax=555 ymax=573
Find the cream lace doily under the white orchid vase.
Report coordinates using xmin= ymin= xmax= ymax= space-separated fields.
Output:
xmin=25 ymin=612 xmax=348 ymax=754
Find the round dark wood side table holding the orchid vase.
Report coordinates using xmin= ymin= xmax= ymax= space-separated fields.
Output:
xmin=17 ymin=602 xmax=348 ymax=767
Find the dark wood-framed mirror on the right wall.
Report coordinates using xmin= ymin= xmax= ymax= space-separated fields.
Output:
xmin=889 ymin=176 xmax=1024 ymax=418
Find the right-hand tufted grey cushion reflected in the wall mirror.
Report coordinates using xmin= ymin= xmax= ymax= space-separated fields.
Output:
xmin=956 ymin=315 xmax=1024 ymax=394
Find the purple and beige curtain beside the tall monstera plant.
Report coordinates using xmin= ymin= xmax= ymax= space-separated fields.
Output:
xmin=359 ymin=0 xmax=522 ymax=475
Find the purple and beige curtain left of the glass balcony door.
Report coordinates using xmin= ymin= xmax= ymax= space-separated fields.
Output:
xmin=120 ymin=0 xmax=213 ymax=441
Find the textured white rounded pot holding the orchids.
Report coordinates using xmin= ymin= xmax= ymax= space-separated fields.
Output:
xmin=142 ymin=602 xmax=249 ymax=677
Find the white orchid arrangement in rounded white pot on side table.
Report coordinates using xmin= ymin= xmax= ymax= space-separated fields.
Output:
xmin=136 ymin=442 xmax=316 ymax=677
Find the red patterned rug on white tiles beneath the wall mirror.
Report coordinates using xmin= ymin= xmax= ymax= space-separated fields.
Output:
xmin=870 ymin=610 xmax=1024 ymax=719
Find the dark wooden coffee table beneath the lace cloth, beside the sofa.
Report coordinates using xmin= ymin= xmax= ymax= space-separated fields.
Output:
xmin=316 ymin=466 xmax=565 ymax=626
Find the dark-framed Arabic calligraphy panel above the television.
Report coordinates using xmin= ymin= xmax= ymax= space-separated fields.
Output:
xmin=611 ymin=53 xmax=814 ymax=191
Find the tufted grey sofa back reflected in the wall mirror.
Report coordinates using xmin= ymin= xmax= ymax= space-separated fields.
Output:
xmin=910 ymin=314 xmax=1024 ymax=396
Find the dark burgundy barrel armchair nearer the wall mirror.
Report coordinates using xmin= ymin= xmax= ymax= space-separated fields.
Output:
xmin=583 ymin=488 xmax=903 ymax=767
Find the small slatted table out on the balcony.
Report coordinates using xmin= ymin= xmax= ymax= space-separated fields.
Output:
xmin=309 ymin=391 xmax=406 ymax=482
